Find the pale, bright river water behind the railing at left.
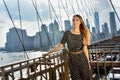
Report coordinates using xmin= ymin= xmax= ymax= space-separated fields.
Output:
xmin=0 ymin=51 xmax=46 ymax=66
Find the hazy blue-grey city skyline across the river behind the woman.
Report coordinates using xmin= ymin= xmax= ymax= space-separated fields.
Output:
xmin=5 ymin=12 xmax=120 ymax=52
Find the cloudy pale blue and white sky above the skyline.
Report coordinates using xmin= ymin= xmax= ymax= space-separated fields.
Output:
xmin=0 ymin=0 xmax=120 ymax=47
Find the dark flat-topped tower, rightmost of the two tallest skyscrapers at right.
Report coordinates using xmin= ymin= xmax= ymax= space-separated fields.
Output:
xmin=110 ymin=12 xmax=117 ymax=36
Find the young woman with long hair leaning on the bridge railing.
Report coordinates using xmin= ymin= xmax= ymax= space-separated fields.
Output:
xmin=43 ymin=14 xmax=90 ymax=80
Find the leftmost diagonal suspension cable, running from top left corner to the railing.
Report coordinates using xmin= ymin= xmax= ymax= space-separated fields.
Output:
xmin=3 ymin=0 xmax=29 ymax=59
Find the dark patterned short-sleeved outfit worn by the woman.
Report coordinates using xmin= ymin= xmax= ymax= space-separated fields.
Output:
xmin=61 ymin=31 xmax=90 ymax=80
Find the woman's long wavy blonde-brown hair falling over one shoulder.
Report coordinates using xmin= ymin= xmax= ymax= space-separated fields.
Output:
xmin=73 ymin=14 xmax=91 ymax=46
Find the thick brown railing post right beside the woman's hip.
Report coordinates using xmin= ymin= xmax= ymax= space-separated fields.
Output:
xmin=63 ymin=49 xmax=70 ymax=80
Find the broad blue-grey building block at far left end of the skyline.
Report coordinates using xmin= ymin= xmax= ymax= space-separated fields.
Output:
xmin=5 ymin=28 xmax=34 ymax=52
